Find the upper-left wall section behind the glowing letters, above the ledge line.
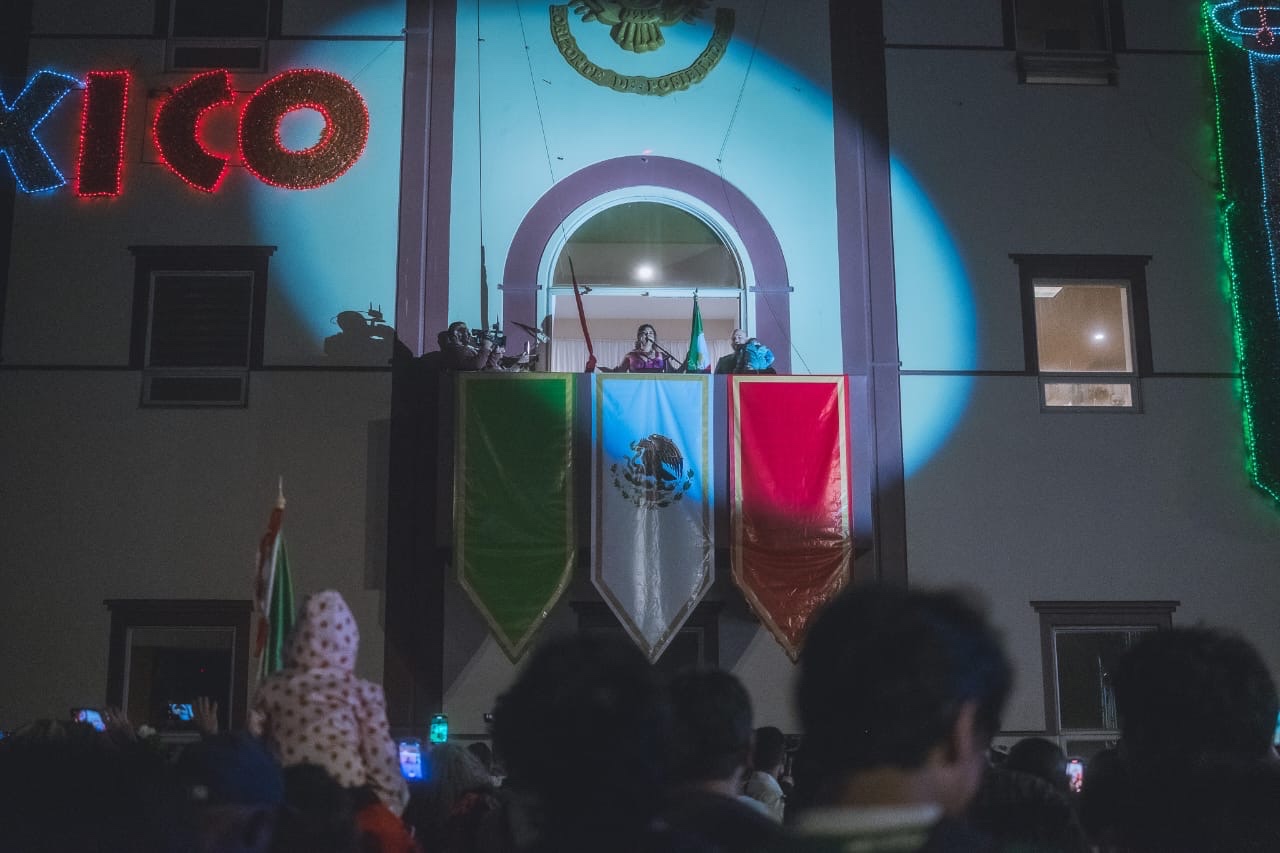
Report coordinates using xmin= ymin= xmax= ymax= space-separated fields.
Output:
xmin=3 ymin=9 xmax=403 ymax=366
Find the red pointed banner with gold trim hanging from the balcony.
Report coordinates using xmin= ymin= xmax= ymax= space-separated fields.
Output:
xmin=728 ymin=377 xmax=854 ymax=660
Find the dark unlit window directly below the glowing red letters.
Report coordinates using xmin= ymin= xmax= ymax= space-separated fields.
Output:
xmin=129 ymin=246 xmax=275 ymax=406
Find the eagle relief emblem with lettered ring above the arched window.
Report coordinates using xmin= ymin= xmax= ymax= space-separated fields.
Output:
xmin=550 ymin=0 xmax=733 ymax=95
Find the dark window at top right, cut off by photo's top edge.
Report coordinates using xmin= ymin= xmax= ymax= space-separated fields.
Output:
xmin=1005 ymin=0 xmax=1124 ymax=86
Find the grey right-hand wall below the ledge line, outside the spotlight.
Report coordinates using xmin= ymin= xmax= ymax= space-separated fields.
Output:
xmin=904 ymin=377 xmax=1280 ymax=730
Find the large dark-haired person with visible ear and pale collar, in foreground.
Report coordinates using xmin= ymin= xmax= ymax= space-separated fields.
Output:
xmin=786 ymin=584 xmax=1011 ymax=853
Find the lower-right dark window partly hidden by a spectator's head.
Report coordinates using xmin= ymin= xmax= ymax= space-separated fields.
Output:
xmin=1030 ymin=601 xmax=1179 ymax=756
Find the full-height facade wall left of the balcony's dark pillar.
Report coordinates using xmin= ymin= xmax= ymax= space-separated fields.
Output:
xmin=0 ymin=0 xmax=404 ymax=729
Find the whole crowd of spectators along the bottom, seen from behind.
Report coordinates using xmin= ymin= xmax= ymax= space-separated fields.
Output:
xmin=0 ymin=585 xmax=1280 ymax=853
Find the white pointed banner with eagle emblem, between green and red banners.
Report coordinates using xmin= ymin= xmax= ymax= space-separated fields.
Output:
xmin=591 ymin=374 xmax=716 ymax=661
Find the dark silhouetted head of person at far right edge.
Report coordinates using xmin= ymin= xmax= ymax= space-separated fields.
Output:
xmin=1085 ymin=628 xmax=1280 ymax=853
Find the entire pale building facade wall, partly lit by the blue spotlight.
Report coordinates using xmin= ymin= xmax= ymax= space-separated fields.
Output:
xmin=0 ymin=0 xmax=1280 ymax=734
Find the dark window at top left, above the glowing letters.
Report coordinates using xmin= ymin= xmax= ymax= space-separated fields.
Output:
xmin=156 ymin=0 xmax=275 ymax=70
